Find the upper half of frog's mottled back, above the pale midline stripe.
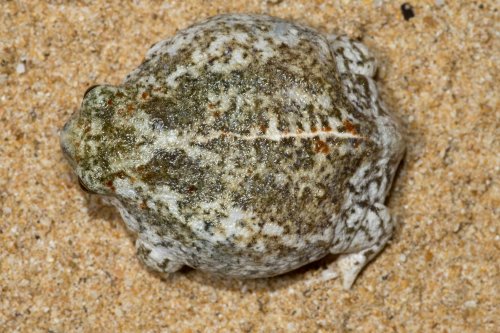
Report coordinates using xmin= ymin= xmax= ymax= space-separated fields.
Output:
xmin=125 ymin=15 xmax=376 ymax=139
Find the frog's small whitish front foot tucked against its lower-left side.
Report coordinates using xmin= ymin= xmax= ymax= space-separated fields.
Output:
xmin=135 ymin=238 xmax=184 ymax=273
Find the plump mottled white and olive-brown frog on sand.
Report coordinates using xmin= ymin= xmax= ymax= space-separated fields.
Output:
xmin=60 ymin=14 xmax=405 ymax=289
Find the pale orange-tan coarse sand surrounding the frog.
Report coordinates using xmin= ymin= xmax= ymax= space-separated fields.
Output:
xmin=0 ymin=0 xmax=500 ymax=332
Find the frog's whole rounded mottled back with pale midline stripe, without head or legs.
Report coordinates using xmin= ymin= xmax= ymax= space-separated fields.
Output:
xmin=99 ymin=15 xmax=379 ymax=277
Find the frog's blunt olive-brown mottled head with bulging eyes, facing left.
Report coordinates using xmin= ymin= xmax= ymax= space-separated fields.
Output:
xmin=61 ymin=85 xmax=137 ymax=195
